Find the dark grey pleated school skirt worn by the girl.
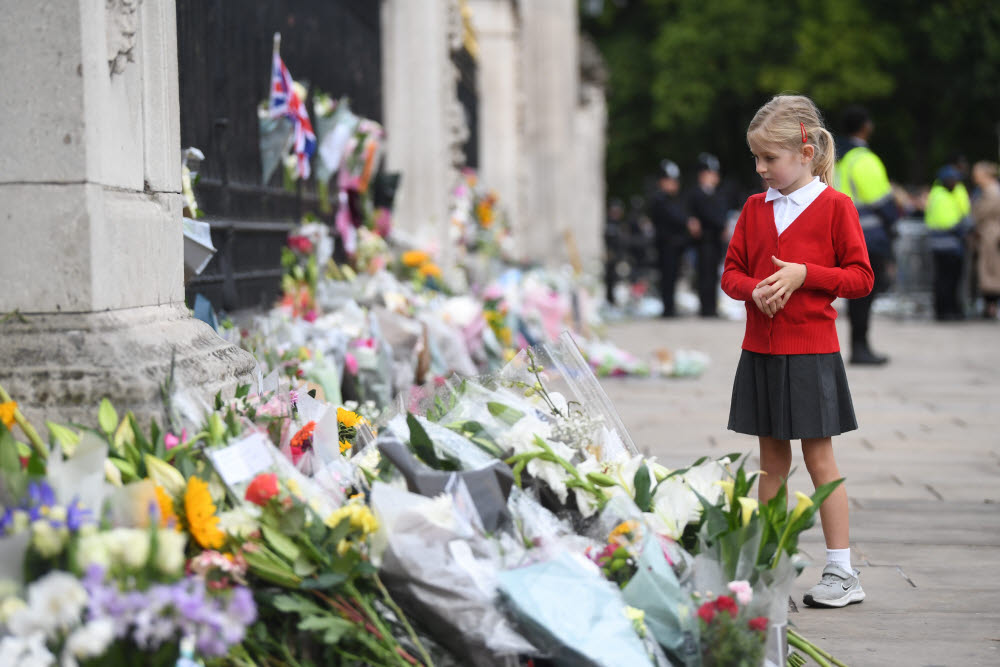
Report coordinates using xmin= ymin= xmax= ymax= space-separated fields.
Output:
xmin=729 ymin=350 xmax=858 ymax=440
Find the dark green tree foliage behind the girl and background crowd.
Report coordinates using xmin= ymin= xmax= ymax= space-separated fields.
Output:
xmin=582 ymin=0 xmax=1000 ymax=197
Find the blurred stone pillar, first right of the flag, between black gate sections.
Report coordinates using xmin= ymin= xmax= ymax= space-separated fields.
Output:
xmin=382 ymin=0 xmax=463 ymax=262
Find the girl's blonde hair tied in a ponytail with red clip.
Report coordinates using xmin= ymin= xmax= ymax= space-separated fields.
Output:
xmin=747 ymin=95 xmax=836 ymax=185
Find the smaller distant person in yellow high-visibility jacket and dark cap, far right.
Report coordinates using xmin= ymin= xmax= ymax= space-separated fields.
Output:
xmin=924 ymin=165 xmax=970 ymax=321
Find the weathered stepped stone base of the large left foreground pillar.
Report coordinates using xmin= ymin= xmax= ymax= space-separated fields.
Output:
xmin=0 ymin=304 xmax=257 ymax=431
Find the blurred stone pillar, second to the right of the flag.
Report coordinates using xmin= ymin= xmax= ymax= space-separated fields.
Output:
xmin=469 ymin=0 xmax=526 ymax=248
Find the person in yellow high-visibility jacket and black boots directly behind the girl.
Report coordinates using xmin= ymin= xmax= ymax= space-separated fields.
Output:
xmin=834 ymin=106 xmax=899 ymax=365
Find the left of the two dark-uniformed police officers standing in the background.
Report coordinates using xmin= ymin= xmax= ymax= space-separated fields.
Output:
xmin=648 ymin=160 xmax=688 ymax=317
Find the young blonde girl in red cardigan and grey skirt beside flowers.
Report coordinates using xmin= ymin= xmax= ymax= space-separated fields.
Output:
xmin=722 ymin=95 xmax=874 ymax=607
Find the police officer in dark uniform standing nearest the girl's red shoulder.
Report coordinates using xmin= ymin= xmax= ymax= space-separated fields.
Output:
xmin=687 ymin=153 xmax=727 ymax=317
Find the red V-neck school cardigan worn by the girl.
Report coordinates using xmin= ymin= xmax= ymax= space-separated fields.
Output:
xmin=722 ymin=187 xmax=874 ymax=354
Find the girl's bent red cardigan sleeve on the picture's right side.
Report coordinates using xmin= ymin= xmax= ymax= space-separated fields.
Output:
xmin=802 ymin=199 xmax=875 ymax=299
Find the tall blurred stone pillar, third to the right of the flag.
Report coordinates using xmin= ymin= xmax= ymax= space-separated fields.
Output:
xmin=514 ymin=0 xmax=580 ymax=264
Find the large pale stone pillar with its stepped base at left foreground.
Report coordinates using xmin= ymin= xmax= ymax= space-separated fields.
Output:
xmin=0 ymin=0 xmax=255 ymax=423
